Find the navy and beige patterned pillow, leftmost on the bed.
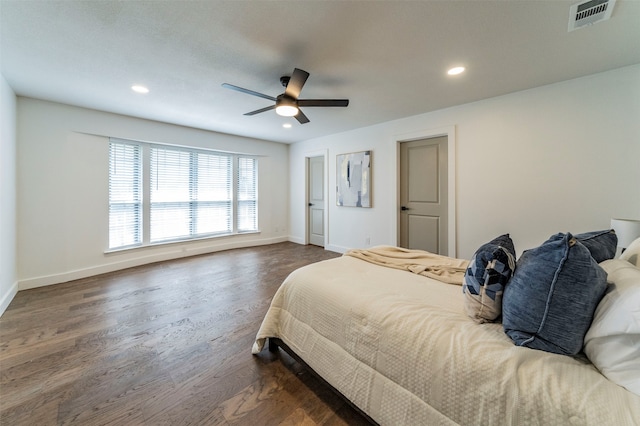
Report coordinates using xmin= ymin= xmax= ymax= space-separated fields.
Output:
xmin=462 ymin=234 xmax=516 ymax=323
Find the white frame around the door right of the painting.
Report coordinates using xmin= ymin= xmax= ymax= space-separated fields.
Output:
xmin=391 ymin=125 xmax=458 ymax=257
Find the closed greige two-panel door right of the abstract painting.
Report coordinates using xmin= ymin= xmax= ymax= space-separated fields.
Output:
xmin=399 ymin=136 xmax=449 ymax=255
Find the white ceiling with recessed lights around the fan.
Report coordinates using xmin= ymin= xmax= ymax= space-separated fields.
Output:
xmin=0 ymin=0 xmax=640 ymax=143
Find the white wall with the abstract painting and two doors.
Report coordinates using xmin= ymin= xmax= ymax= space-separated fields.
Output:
xmin=289 ymin=65 xmax=640 ymax=258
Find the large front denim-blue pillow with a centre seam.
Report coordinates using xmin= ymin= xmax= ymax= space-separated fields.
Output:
xmin=502 ymin=233 xmax=607 ymax=355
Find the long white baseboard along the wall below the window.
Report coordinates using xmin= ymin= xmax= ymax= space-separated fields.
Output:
xmin=18 ymin=237 xmax=295 ymax=292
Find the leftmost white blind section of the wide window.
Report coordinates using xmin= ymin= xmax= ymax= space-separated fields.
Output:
xmin=109 ymin=142 xmax=142 ymax=248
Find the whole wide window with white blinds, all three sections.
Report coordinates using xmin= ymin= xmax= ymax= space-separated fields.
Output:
xmin=109 ymin=139 xmax=258 ymax=249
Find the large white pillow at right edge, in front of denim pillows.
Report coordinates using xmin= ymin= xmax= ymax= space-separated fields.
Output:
xmin=584 ymin=259 xmax=640 ymax=396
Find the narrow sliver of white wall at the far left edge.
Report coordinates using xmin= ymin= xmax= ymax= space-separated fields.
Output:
xmin=0 ymin=75 xmax=18 ymax=315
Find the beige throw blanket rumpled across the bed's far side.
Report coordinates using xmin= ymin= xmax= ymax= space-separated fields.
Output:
xmin=344 ymin=246 xmax=469 ymax=285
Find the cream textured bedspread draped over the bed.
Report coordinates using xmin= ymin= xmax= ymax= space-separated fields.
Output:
xmin=252 ymin=238 xmax=640 ymax=426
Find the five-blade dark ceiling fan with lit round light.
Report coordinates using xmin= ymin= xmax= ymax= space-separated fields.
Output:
xmin=222 ymin=68 xmax=349 ymax=124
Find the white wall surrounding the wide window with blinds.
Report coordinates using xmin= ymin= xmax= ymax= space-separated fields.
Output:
xmin=17 ymin=97 xmax=289 ymax=289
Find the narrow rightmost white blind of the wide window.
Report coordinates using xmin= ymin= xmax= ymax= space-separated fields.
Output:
xmin=237 ymin=157 xmax=258 ymax=232
